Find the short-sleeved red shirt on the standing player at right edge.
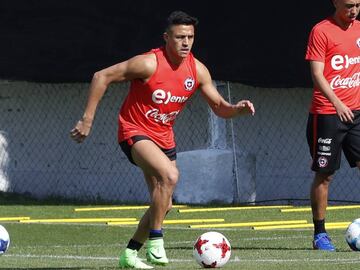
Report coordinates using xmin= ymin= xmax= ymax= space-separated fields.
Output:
xmin=305 ymin=17 xmax=360 ymax=114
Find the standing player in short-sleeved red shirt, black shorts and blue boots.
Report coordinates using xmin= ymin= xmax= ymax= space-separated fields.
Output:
xmin=305 ymin=0 xmax=360 ymax=251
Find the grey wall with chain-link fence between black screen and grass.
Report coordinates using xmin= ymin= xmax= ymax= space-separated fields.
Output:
xmin=0 ymin=81 xmax=359 ymax=203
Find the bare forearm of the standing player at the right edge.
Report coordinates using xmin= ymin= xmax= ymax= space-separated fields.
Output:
xmin=310 ymin=61 xmax=354 ymax=122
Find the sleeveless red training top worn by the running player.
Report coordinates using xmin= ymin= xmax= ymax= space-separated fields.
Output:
xmin=118 ymin=48 xmax=198 ymax=149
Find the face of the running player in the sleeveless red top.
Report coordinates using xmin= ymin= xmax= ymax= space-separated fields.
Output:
xmin=164 ymin=25 xmax=194 ymax=59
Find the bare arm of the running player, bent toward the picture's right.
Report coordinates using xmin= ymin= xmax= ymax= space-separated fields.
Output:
xmin=196 ymin=60 xmax=255 ymax=118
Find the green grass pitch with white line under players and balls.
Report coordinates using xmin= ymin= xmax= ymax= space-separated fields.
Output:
xmin=0 ymin=198 xmax=360 ymax=270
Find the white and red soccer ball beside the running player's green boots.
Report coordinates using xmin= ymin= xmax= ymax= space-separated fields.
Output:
xmin=193 ymin=232 xmax=231 ymax=268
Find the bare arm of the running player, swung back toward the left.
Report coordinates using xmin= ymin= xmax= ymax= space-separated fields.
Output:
xmin=70 ymin=54 xmax=156 ymax=143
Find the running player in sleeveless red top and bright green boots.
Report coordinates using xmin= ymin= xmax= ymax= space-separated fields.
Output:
xmin=70 ymin=11 xmax=255 ymax=269
